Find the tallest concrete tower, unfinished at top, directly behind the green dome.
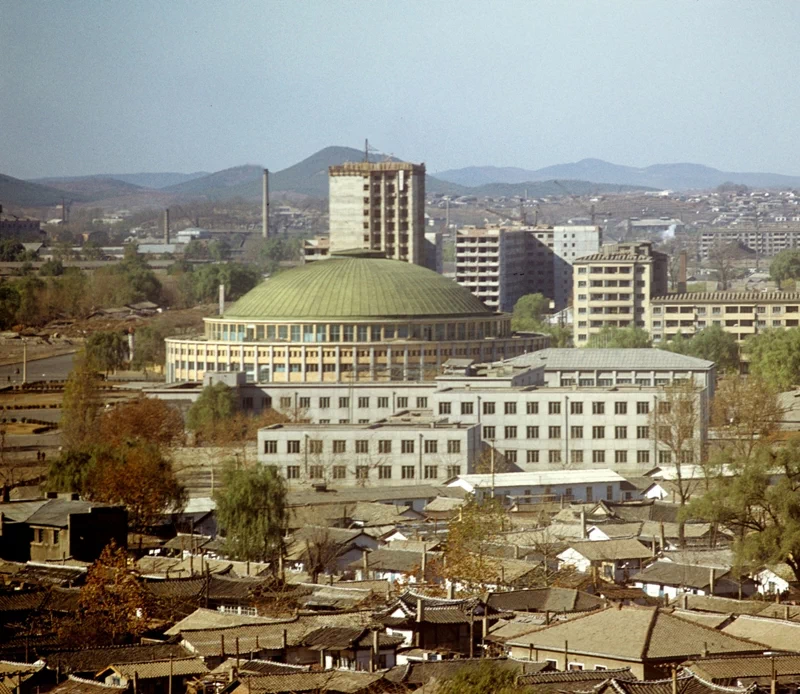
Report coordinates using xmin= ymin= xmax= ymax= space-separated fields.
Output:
xmin=328 ymin=162 xmax=428 ymax=269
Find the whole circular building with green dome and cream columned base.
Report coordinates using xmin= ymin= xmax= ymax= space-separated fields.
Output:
xmin=166 ymin=251 xmax=546 ymax=383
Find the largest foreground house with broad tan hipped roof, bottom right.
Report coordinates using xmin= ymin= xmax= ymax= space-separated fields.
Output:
xmin=506 ymin=606 xmax=765 ymax=679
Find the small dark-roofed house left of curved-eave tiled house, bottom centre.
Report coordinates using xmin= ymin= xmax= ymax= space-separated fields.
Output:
xmin=303 ymin=626 xmax=404 ymax=672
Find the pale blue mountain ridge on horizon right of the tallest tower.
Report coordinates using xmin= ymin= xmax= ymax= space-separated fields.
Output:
xmin=436 ymin=159 xmax=800 ymax=190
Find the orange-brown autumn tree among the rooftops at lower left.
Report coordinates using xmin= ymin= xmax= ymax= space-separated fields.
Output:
xmin=59 ymin=542 xmax=153 ymax=646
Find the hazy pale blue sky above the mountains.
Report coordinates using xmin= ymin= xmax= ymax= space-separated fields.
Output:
xmin=0 ymin=0 xmax=800 ymax=178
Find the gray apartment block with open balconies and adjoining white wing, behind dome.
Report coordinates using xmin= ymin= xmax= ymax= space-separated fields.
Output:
xmin=456 ymin=226 xmax=602 ymax=312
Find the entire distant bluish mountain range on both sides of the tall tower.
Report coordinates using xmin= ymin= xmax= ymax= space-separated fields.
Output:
xmin=7 ymin=147 xmax=788 ymax=208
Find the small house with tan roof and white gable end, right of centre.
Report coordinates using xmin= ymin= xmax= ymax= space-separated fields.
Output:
xmin=558 ymin=539 xmax=652 ymax=583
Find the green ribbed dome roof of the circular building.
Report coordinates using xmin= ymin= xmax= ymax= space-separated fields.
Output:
xmin=225 ymin=254 xmax=493 ymax=320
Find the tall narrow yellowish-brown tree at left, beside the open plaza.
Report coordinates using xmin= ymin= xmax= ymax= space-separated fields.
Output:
xmin=58 ymin=356 xmax=100 ymax=451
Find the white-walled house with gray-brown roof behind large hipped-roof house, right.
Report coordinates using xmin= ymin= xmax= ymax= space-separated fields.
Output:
xmin=632 ymin=561 xmax=755 ymax=600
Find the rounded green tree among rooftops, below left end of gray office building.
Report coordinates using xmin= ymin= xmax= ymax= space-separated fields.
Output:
xmin=214 ymin=461 xmax=287 ymax=571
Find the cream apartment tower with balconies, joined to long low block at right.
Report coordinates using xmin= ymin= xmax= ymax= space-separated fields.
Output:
xmin=573 ymin=241 xmax=669 ymax=347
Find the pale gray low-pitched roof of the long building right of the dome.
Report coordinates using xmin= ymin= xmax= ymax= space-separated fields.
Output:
xmin=507 ymin=347 xmax=714 ymax=371
